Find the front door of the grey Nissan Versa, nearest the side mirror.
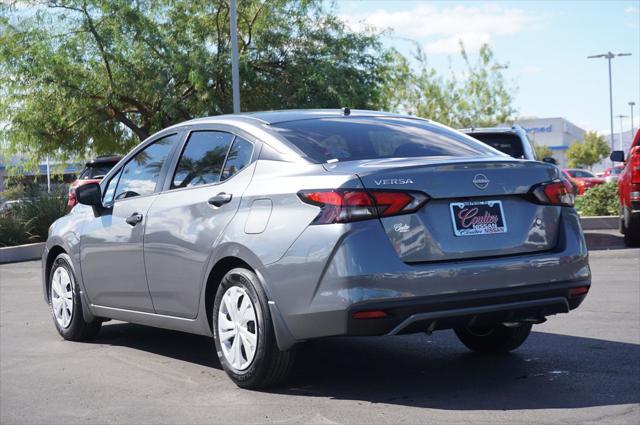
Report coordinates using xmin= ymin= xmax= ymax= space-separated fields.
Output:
xmin=80 ymin=133 xmax=179 ymax=312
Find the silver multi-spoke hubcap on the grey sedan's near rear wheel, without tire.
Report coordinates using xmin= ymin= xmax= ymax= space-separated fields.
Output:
xmin=218 ymin=286 xmax=258 ymax=371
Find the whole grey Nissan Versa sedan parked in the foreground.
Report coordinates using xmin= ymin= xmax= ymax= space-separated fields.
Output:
xmin=42 ymin=108 xmax=591 ymax=388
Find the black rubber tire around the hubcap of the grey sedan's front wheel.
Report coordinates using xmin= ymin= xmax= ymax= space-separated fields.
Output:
xmin=48 ymin=254 xmax=102 ymax=341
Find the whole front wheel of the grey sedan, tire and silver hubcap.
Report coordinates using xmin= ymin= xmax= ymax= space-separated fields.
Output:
xmin=49 ymin=254 xmax=102 ymax=341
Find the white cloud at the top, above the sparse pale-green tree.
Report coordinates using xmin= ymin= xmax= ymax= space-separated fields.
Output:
xmin=342 ymin=4 xmax=540 ymax=53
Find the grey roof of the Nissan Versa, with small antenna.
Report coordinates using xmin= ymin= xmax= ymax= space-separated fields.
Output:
xmin=180 ymin=108 xmax=429 ymax=125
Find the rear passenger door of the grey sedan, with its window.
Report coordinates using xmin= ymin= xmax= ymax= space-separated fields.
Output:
xmin=144 ymin=130 xmax=254 ymax=318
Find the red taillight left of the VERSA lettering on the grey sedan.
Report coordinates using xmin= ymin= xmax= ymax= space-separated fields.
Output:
xmin=298 ymin=189 xmax=429 ymax=224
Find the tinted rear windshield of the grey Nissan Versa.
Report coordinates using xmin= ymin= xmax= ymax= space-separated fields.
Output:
xmin=271 ymin=117 xmax=500 ymax=162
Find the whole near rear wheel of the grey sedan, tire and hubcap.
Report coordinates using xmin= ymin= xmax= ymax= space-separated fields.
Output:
xmin=212 ymin=268 xmax=294 ymax=389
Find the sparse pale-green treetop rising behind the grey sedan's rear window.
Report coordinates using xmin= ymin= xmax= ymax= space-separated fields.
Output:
xmin=383 ymin=43 xmax=515 ymax=128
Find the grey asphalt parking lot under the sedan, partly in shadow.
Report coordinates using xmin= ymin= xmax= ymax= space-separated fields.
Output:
xmin=0 ymin=234 xmax=640 ymax=424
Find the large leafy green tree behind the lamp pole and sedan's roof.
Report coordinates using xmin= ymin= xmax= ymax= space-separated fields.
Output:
xmin=0 ymin=0 xmax=390 ymax=157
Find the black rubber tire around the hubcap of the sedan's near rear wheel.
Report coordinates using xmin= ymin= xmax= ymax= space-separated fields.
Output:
xmin=211 ymin=268 xmax=295 ymax=389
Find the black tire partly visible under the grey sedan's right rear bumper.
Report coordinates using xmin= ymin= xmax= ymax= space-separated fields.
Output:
xmin=455 ymin=324 xmax=531 ymax=354
